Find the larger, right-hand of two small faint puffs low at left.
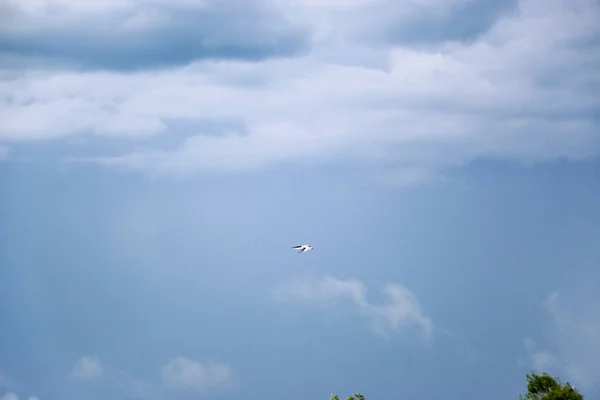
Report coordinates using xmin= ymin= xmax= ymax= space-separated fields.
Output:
xmin=161 ymin=357 xmax=233 ymax=393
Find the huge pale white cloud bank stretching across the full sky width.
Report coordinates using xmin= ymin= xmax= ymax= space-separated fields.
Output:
xmin=0 ymin=0 xmax=600 ymax=184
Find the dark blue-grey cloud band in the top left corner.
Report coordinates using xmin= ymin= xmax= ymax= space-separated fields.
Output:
xmin=0 ymin=0 xmax=310 ymax=70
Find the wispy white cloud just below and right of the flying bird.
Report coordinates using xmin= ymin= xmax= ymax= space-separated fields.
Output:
xmin=274 ymin=276 xmax=434 ymax=340
